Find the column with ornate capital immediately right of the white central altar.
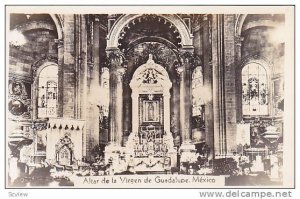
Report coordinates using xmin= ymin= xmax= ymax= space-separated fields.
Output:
xmin=177 ymin=49 xmax=196 ymax=162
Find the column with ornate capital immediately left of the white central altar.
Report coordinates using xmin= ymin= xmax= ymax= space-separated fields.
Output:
xmin=105 ymin=49 xmax=125 ymax=162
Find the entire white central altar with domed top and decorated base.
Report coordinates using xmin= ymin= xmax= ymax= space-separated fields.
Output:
xmin=126 ymin=54 xmax=177 ymax=171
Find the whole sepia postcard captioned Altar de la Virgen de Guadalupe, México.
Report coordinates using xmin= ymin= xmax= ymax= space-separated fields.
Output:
xmin=4 ymin=5 xmax=295 ymax=189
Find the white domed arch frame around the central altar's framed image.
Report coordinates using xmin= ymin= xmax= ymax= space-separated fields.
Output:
xmin=129 ymin=54 xmax=172 ymax=133
